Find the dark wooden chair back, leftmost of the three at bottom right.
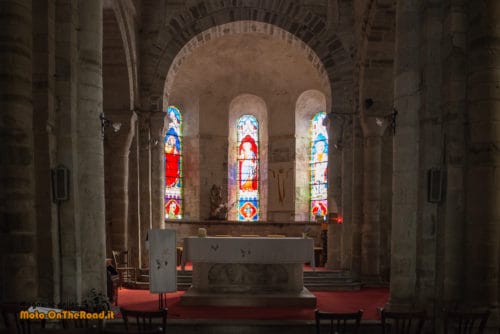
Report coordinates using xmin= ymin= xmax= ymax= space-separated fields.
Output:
xmin=314 ymin=309 xmax=363 ymax=334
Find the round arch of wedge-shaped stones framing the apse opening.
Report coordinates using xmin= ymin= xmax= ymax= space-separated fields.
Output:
xmin=141 ymin=0 xmax=354 ymax=112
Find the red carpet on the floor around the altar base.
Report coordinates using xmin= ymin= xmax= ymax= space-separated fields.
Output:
xmin=118 ymin=288 xmax=389 ymax=320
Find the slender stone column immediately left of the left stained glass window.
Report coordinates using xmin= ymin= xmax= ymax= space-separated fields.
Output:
xmin=150 ymin=111 xmax=166 ymax=228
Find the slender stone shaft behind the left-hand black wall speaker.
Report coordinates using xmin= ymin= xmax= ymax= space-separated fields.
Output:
xmin=54 ymin=0 xmax=80 ymax=302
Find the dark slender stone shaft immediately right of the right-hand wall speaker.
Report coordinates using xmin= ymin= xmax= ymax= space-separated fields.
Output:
xmin=436 ymin=0 xmax=467 ymax=307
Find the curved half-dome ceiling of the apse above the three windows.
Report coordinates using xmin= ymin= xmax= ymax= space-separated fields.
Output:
xmin=166 ymin=32 xmax=330 ymax=111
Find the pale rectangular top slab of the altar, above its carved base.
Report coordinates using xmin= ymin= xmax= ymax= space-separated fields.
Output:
xmin=182 ymin=237 xmax=314 ymax=266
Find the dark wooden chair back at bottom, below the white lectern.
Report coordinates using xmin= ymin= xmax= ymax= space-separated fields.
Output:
xmin=120 ymin=307 xmax=168 ymax=333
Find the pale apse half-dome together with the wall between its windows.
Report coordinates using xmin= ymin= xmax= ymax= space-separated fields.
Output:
xmin=161 ymin=21 xmax=331 ymax=221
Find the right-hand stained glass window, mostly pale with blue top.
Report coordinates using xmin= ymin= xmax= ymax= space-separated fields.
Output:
xmin=309 ymin=112 xmax=328 ymax=220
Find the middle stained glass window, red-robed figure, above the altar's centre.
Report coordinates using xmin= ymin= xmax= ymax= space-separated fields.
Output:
xmin=236 ymin=115 xmax=259 ymax=221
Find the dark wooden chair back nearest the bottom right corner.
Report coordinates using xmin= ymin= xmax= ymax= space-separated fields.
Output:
xmin=444 ymin=310 xmax=490 ymax=334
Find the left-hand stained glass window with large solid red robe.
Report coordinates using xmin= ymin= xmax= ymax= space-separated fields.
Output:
xmin=164 ymin=106 xmax=184 ymax=219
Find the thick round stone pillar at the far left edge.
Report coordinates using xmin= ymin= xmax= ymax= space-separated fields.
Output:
xmin=0 ymin=0 xmax=38 ymax=302
